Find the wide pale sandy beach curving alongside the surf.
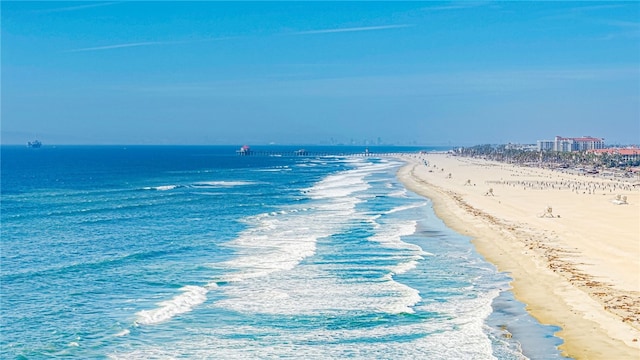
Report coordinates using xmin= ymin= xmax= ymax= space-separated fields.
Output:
xmin=398 ymin=154 xmax=640 ymax=359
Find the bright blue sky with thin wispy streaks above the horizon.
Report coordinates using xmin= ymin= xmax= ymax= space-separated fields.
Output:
xmin=1 ymin=1 xmax=640 ymax=145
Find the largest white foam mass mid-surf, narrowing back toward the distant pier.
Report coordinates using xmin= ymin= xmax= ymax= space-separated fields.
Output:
xmin=210 ymin=160 xmax=428 ymax=314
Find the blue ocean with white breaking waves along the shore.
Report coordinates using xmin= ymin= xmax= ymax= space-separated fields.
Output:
xmin=0 ymin=145 xmax=561 ymax=359
